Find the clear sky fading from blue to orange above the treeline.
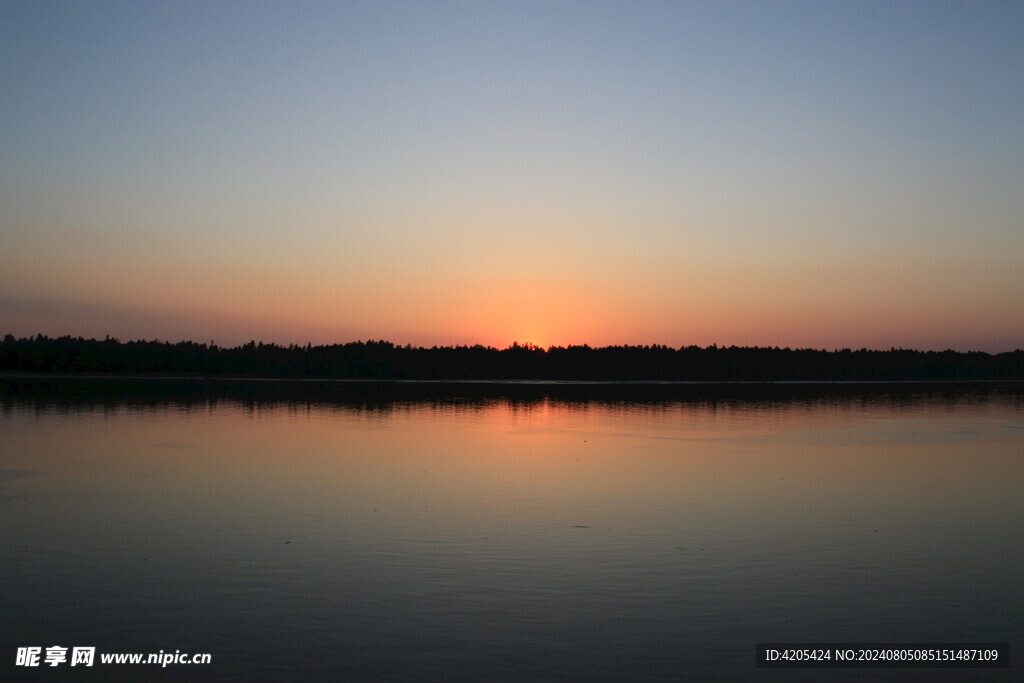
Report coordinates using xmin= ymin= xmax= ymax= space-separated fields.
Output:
xmin=0 ymin=0 xmax=1024 ymax=352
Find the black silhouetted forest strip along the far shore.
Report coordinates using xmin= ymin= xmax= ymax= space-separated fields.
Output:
xmin=0 ymin=334 xmax=1024 ymax=381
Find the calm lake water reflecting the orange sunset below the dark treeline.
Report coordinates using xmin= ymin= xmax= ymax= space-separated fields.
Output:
xmin=0 ymin=381 xmax=1024 ymax=681
